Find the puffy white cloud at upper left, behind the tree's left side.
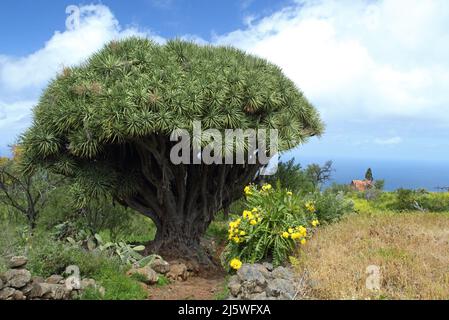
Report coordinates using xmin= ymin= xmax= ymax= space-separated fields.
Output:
xmin=0 ymin=5 xmax=163 ymax=92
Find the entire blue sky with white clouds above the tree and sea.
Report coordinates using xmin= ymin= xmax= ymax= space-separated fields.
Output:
xmin=0 ymin=0 xmax=449 ymax=163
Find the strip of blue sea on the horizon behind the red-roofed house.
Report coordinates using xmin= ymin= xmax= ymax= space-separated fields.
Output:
xmin=282 ymin=155 xmax=449 ymax=191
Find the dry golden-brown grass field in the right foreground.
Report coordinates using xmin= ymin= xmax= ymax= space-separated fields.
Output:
xmin=298 ymin=212 xmax=449 ymax=299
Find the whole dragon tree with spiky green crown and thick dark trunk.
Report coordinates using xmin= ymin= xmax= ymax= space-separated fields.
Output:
xmin=21 ymin=38 xmax=323 ymax=262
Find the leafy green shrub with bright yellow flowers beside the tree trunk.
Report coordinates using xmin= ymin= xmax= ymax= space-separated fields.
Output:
xmin=222 ymin=184 xmax=319 ymax=270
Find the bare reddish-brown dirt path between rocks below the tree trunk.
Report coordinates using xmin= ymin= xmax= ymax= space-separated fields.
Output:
xmin=148 ymin=275 xmax=224 ymax=300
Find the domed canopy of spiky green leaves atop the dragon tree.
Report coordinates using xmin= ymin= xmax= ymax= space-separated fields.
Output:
xmin=23 ymin=38 xmax=323 ymax=190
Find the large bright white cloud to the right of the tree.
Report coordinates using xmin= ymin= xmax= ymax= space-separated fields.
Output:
xmin=214 ymin=0 xmax=449 ymax=123
